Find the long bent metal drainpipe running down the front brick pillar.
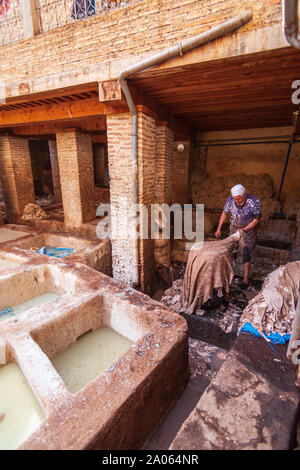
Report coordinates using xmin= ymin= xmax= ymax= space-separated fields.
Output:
xmin=118 ymin=10 xmax=253 ymax=285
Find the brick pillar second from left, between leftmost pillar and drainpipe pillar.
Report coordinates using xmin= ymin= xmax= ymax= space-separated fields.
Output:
xmin=56 ymin=129 xmax=96 ymax=227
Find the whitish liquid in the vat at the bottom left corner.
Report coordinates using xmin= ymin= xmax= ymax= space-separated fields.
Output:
xmin=0 ymin=363 xmax=44 ymax=450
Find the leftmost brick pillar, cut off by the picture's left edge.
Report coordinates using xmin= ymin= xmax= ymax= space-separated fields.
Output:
xmin=0 ymin=136 xmax=35 ymax=223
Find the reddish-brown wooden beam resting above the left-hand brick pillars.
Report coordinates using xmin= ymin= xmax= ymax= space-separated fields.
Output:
xmin=0 ymin=98 xmax=128 ymax=127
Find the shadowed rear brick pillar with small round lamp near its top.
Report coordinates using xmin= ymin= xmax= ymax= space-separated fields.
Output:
xmin=172 ymin=141 xmax=191 ymax=204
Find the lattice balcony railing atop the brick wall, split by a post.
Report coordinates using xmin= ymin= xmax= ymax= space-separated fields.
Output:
xmin=0 ymin=0 xmax=140 ymax=46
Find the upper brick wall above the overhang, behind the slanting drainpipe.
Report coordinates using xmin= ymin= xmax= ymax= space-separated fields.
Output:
xmin=0 ymin=0 xmax=281 ymax=81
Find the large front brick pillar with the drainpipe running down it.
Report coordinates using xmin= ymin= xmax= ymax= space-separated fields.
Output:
xmin=107 ymin=113 xmax=155 ymax=291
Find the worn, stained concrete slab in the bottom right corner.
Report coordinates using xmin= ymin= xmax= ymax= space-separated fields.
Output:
xmin=170 ymin=335 xmax=300 ymax=450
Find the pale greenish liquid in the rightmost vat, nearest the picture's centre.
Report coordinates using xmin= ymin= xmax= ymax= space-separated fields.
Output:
xmin=51 ymin=328 xmax=132 ymax=393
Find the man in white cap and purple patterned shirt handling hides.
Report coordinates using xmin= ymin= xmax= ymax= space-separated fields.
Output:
xmin=215 ymin=184 xmax=261 ymax=289
